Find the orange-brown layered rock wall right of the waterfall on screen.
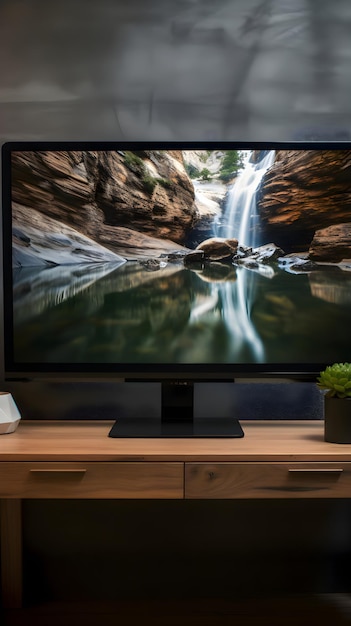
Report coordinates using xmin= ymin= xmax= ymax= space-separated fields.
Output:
xmin=258 ymin=150 xmax=351 ymax=260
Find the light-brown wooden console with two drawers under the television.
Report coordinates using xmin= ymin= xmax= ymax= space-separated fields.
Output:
xmin=0 ymin=420 xmax=351 ymax=608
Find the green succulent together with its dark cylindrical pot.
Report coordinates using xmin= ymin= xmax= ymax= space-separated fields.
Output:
xmin=317 ymin=363 xmax=351 ymax=443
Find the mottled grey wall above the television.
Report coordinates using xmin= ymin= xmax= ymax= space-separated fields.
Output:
xmin=0 ymin=0 xmax=351 ymax=141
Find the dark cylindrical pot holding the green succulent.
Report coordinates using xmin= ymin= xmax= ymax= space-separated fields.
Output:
xmin=324 ymin=397 xmax=351 ymax=443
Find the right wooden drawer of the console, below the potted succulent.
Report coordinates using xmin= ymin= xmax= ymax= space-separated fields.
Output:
xmin=185 ymin=463 xmax=351 ymax=499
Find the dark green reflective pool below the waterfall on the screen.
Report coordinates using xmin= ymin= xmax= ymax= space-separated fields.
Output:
xmin=14 ymin=263 xmax=351 ymax=364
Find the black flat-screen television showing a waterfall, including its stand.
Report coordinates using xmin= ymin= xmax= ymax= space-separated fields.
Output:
xmin=2 ymin=142 xmax=351 ymax=437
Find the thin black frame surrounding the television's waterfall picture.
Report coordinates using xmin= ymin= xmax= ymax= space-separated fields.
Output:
xmin=2 ymin=140 xmax=351 ymax=381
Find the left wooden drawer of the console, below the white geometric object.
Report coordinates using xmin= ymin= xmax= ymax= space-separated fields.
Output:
xmin=0 ymin=462 xmax=184 ymax=498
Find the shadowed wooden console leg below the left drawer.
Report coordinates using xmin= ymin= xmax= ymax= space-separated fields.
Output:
xmin=0 ymin=499 xmax=22 ymax=609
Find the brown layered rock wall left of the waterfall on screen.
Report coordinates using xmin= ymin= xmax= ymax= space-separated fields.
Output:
xmin=12 ymin=151 xmax=196 ymax=257
